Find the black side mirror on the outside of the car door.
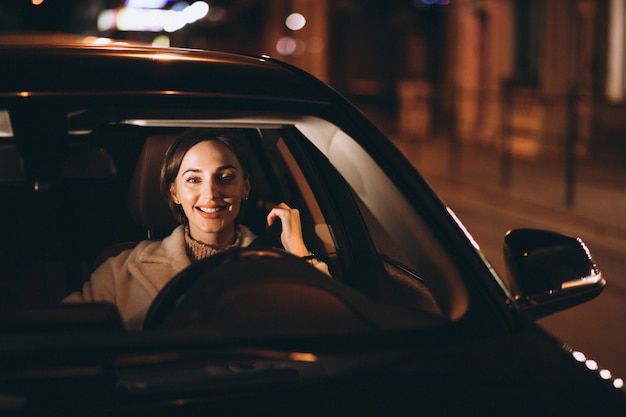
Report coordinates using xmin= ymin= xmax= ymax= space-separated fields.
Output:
xmin=504 ymin=229 xmax=606 ymax=320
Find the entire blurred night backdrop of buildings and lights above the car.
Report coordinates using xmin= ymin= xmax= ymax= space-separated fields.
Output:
xmin=0 ymin=0 xmax=626 ymax=164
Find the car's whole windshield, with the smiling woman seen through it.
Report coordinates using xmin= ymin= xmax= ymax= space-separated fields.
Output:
xmin=0 ymin=106 xmax=467 ymax=337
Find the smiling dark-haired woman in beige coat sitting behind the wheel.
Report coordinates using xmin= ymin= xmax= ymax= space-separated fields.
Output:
xmin=64 ymin=129 xmax=328 ymax=331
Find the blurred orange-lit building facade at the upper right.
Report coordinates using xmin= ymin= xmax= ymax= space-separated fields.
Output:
xmin=441 ymin=0 xmax=626 ymax=169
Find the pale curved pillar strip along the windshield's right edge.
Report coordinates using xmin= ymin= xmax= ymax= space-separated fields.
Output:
xmin=296 ymin=119 xmax=468 ymax=319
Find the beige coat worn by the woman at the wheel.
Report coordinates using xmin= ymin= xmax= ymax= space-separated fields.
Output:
xmin=63 ymin=226 xmax=255 ymax=331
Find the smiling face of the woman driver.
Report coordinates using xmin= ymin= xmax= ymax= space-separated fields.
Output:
xmin=170 ymin=140 xmax=250 ymax=246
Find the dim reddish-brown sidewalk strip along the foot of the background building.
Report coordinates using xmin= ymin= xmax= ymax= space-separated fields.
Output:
xmin=392 ymin=137 xmax=626 ymax=237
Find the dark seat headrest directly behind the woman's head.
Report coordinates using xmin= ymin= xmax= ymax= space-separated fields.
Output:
xmin=128 ymin=135 xmax=178 ymax=235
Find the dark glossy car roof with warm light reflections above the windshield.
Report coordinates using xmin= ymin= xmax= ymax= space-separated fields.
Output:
xmin=0 ymin=34 xmax=331 ymax=102
